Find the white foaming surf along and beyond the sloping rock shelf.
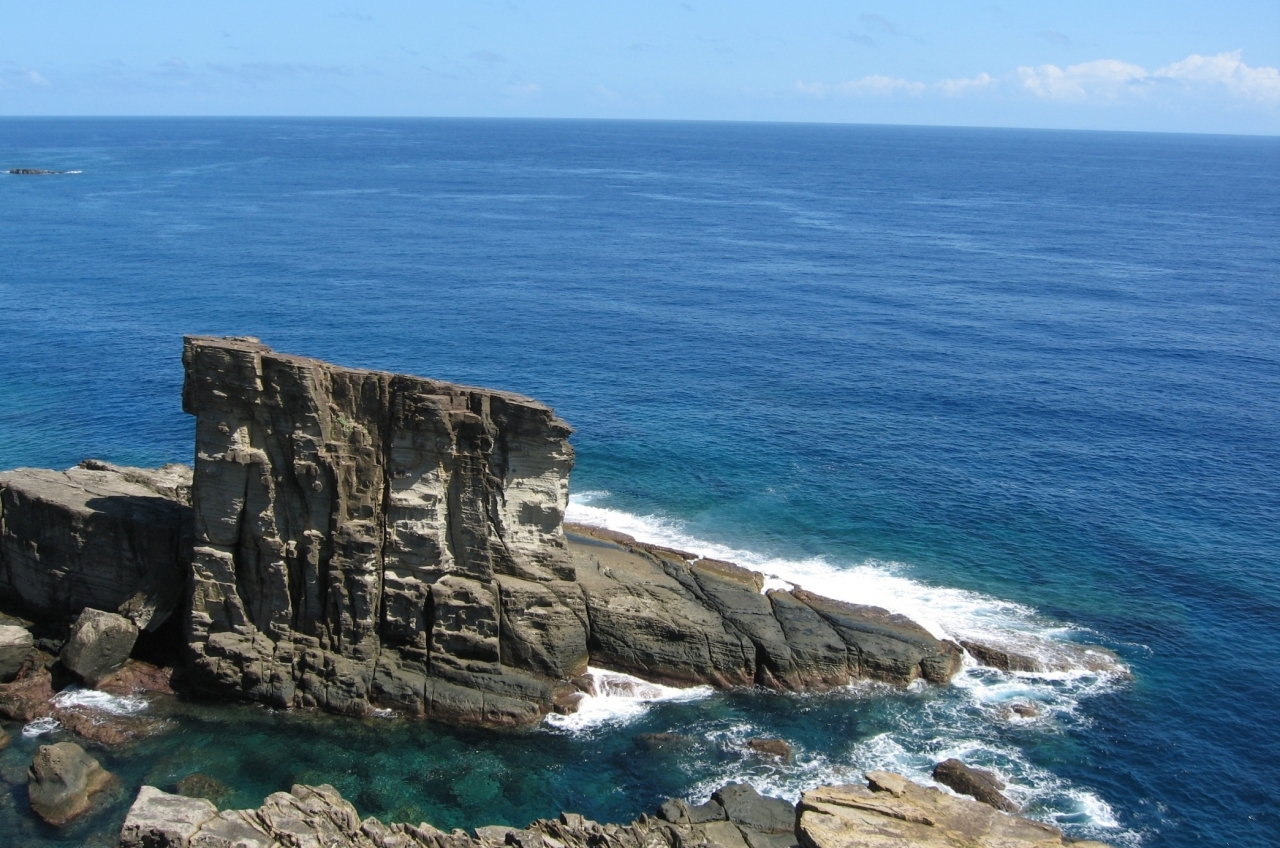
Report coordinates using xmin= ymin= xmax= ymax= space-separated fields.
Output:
xmin=565 ymin=492 xmax=1140 ymax=844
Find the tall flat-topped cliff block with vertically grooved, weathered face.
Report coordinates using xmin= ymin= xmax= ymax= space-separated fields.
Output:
xmin=183 ymin=338 xmax=576 ymax=722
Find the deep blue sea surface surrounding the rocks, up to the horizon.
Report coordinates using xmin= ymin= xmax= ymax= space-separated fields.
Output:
xmin=0 ymin=119 xmax=1280 ymax=847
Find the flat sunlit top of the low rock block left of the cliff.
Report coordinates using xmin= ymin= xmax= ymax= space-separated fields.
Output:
xmin=0 ymin=460 xmax=192 ymax=514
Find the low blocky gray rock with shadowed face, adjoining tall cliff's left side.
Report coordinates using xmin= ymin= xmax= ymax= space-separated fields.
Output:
xmin=0 ymin=460 xmax=191 ymax=630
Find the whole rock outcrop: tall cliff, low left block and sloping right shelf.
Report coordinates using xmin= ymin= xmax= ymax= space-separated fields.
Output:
xmin=0 ymin=337 xmax=961 ymax=725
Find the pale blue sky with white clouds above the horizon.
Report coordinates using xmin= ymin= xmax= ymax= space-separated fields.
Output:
xmin=0 ymin=0 xmax=1280 ymax=135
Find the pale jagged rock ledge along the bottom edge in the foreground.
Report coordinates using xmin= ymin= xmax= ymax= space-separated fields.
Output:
xmin=119 ymin=771 xmax=1105 ymax=848
